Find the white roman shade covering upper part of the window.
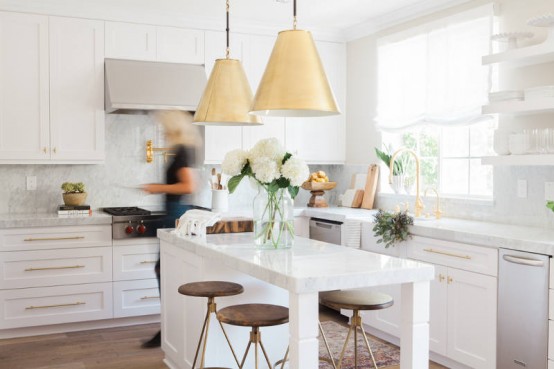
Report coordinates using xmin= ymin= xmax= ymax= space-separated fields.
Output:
xmin=375 ymin=5 xmax=493 ymax=131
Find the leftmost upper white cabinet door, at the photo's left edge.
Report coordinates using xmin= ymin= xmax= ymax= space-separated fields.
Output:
xmin=0 ymin=12 xmax=50 ymax=161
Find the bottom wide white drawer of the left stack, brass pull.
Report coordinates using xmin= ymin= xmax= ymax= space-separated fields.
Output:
xmin=0 ymin=283 xmax=113 ymax=329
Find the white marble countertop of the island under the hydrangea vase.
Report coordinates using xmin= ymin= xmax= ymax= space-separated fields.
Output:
xmin=158 ymin=229 xmax=434 ymax=293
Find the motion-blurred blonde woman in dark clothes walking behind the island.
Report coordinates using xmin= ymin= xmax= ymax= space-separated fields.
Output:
xmin=142 ymin=111 xmax=202 ymax=348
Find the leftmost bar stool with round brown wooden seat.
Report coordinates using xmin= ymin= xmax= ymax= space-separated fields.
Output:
xmin=178 ymin=281 xmax=244 ymax=369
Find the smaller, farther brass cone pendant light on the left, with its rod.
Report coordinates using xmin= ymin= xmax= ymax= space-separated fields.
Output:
xmin=193 ymin=0 xmax=262 ymax=126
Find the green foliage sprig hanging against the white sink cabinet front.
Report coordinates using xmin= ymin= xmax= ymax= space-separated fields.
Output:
xmin=373 ymin=209 xmax=414 ymax=248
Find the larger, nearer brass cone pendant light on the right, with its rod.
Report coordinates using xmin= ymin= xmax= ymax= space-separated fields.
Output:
xmin=250 ymin=0 xmax=340 ymax=117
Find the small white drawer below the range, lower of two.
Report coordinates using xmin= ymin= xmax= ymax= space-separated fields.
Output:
xmin=113 ymin=279 xmax=160 ymax=318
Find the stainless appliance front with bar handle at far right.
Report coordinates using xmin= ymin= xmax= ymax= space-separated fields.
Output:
xmin=496 ymin=249 xmax=549 ymax=369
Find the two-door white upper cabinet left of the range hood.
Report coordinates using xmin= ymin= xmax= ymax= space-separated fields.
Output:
xmin=0 ymin=13 xmax=104 ymax=164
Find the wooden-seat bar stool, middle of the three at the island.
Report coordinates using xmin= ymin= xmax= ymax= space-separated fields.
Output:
xmin=217 ymin=304 xmax=289 ymax=369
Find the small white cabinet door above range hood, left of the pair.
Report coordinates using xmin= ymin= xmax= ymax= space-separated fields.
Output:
xmin=105 ymin=22 xmax=156 ymax=61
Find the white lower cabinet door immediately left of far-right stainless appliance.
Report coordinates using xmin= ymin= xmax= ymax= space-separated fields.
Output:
xmin=447 ymin=268 xmax=497 ymax=369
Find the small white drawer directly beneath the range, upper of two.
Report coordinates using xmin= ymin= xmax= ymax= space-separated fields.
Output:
xmin=113 ymin=242 xmax=160 ymax=281
